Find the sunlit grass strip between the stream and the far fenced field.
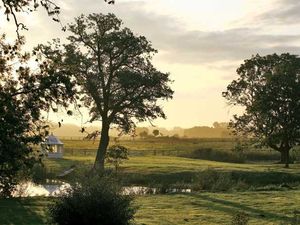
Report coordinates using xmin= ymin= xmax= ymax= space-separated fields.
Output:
xmin=38 ymin=156 xmax=300 ymax=188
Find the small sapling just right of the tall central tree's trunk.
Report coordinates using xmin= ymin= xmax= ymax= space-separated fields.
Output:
xmin=106 ymin=145 xmax=128 ymax=172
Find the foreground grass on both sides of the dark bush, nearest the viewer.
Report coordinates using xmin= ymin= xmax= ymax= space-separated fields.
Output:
xmin=0 ymin=191 xmax=300 ymax=225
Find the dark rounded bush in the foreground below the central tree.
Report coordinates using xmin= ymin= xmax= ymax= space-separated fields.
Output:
xmin=49 ymin=176 xmax=136 ymax=225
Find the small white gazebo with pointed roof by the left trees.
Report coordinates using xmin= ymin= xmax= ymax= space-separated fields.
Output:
xmin=42 ymin=134 xmax=64 ymax=158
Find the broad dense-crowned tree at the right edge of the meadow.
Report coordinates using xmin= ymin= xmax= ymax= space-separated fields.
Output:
xmin=223 ymin=53 xmax=300 ymax=167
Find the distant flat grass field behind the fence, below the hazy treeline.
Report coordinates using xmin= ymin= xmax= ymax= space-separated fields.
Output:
xmin=63 ymin=137 xmax=300 ymax=162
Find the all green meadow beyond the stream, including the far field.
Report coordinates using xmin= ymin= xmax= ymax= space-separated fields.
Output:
xmin=44 ymin=138 xmax=300 ymax=186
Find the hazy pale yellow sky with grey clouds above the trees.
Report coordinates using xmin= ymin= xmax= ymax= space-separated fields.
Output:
xmin=0 ymin=0 xmax=300 ymax=127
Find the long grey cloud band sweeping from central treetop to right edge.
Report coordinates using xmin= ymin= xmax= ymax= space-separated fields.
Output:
xmin=100 ymin=0 xmax=300 ymax=64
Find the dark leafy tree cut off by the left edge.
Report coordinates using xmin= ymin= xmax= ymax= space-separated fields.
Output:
xmin=0 ymin=35 xmax=74 ymax=196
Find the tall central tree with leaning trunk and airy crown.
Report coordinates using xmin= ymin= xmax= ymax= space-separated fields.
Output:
xmin=39 ymin=14 xmax=173 ymax=169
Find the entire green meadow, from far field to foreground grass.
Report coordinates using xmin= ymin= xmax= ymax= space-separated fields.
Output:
xmin=0 ymin=139 xmax=300 ymax=225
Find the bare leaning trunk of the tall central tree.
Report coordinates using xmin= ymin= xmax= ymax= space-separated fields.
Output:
xmin=94 ymin=121 xmax=109 ymax=171
